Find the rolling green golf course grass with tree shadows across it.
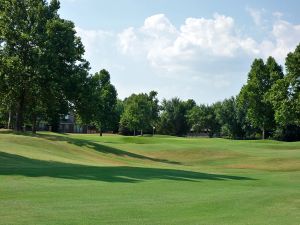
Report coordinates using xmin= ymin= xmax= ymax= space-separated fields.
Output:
xmin=0 ymin=132 xmax=300 ymax=225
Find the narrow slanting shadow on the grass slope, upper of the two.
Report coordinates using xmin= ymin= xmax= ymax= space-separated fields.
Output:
xmin=0 ymin=131 xmax=181 ymax=165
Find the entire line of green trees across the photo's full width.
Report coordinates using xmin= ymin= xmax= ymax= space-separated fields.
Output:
xmin=0 ymin=0 xmax=300 ymax=140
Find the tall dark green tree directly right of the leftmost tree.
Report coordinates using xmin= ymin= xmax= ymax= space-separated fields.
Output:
xmin=41 ymin=4 xmax=89 ymax=130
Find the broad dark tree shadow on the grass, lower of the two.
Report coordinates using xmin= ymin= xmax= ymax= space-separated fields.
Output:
xmin=0 ymin=152 xmax=254 ymax=183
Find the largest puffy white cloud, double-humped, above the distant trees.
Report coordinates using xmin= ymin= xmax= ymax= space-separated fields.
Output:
xmin=119 ymin=14 xmax=258 ymax=72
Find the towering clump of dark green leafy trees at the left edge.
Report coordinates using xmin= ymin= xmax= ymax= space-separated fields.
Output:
xmin=0 ymin=0 xmax=89 ymax=131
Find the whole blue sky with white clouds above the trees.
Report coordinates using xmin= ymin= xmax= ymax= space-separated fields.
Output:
xmin=59 ymin=0 xmax=300 ymax=104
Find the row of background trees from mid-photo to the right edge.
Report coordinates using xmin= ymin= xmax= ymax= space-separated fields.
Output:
xmin=120 ymin=49 xmax=300 ymax=141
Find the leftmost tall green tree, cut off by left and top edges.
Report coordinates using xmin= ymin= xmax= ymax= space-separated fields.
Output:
xmin=0 ymin=0 xmax=46 ymax=130
